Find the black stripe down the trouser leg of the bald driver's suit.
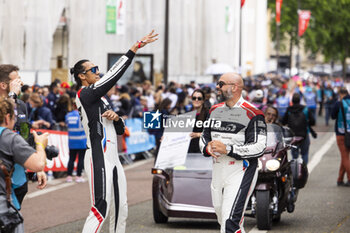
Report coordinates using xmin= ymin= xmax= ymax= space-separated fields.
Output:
xmin=226 ymin=159 xmax=258 ymax=233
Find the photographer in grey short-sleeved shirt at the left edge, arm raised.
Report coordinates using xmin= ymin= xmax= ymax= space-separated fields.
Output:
xmin=0 ymin=97 xmax=48 ymax=233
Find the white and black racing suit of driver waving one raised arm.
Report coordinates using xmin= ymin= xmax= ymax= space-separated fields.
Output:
xmin=76 ymin=50 xmax=135 ymax=233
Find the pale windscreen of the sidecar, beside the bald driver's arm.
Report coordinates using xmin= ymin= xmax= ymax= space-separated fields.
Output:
xmin=174 ymin=153 xmax=213 ymax=171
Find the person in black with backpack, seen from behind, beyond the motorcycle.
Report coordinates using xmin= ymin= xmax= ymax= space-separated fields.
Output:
xmin=282 ymin=93 xmax=315 ymax=164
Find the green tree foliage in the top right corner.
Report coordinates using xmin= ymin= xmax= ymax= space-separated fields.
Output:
xmin=268 ymin=0 xmax=350 ymax=67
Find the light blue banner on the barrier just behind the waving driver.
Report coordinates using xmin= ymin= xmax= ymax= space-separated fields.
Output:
xmin=125 ymin=118 xmax=156 ymax=154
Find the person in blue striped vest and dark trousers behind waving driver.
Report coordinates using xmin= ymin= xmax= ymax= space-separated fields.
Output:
xmin=63 ymin=99 xmax=86 ymax=183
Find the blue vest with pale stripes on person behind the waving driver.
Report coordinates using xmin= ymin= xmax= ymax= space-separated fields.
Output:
xmin=65 ymin=110 xmax=86 ymax=149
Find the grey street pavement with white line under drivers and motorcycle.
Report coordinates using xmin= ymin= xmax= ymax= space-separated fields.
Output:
xmin=21 ymin=123 xmax=350 ymax=233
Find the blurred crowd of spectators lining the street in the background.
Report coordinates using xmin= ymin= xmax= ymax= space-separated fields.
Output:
xmin=20 ymin=74 xmax=350 ymax=134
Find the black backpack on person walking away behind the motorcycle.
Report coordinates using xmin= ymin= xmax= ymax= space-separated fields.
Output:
xmin=288 ymin=108 xmax=308 ymax=138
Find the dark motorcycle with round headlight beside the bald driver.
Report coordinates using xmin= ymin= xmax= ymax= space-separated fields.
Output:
xmin=247 ymin=124 xmax=308 ymax=230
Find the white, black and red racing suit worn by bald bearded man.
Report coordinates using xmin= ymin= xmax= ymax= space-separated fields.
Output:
xmin=200 ymin=97 xmax=267 ymax=233
